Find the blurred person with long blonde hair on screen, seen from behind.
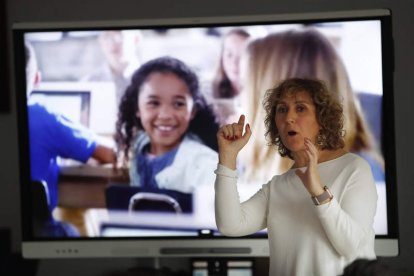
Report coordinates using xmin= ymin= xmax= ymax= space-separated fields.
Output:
xmin=240 ymin=28 xmax=384 ymax=183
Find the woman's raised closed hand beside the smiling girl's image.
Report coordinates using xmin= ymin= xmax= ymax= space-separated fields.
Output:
xmin=217 ymin=115 xmax=252 ymax=169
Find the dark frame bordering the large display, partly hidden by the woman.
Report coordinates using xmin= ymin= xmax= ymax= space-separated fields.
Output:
xmin=12 ymin=9 xmax=399 ymax=258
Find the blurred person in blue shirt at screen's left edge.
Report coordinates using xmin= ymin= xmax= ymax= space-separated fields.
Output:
xmin=25 ymin=43 xmax=116 ymax=212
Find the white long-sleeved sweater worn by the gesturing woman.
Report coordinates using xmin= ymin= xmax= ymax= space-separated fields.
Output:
xmin=215 ymin=153 xmax=377 ymax=276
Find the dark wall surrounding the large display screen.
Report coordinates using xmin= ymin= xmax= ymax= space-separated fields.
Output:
xmin=0 ymin=0 xmax=414 ymax=275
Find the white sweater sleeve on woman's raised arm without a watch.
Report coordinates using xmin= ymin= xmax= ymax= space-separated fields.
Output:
xmin=215 ymin=164 xmax=269 ymax=236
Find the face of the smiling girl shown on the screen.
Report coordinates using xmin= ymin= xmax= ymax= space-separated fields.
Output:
xmin=136 ymin=72 xmax=194 ymax=155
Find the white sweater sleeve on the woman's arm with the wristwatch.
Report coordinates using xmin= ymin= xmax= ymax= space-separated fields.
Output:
xmin=315 ymin=160 xmax=377 ymax=259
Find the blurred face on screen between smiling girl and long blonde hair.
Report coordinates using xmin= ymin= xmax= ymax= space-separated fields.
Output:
xmin=222 ymin=34 xmax=247 ymax=87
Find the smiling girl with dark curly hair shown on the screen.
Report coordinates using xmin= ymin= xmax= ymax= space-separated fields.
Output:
xmin=116 ymin=57 xmax=218 ymax=193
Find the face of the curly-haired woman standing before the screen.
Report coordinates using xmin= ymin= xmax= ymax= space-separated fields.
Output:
xmin=275 ymin=91 xmax=320 ymax=153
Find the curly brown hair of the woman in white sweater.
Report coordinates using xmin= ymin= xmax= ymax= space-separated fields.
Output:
xmin=263 ymin=78 xmax=345 ymax=159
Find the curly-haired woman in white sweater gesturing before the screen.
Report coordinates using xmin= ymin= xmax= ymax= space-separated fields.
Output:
xmin=215 ymin=78 xmax=377 ymax=276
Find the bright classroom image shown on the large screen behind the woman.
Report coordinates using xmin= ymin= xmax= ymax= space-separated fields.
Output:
xmin=25 ymin=20 xmax=388 ymax=238
